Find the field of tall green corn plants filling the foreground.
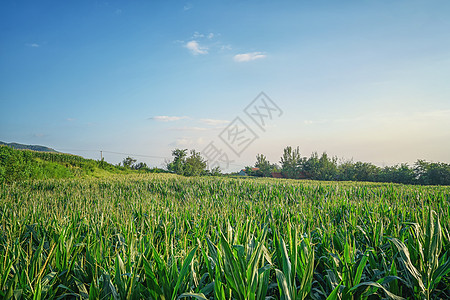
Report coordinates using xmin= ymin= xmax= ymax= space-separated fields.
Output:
xmin=0 ymin=174 xmax=450 ymax=300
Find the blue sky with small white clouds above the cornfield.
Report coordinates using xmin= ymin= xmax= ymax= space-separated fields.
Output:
xmin=0 ymin=0 xmax=450 ymax=169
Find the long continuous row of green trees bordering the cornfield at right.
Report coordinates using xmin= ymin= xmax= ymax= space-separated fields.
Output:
xmin=246 ymin=146 xmax=450 ymax=185
